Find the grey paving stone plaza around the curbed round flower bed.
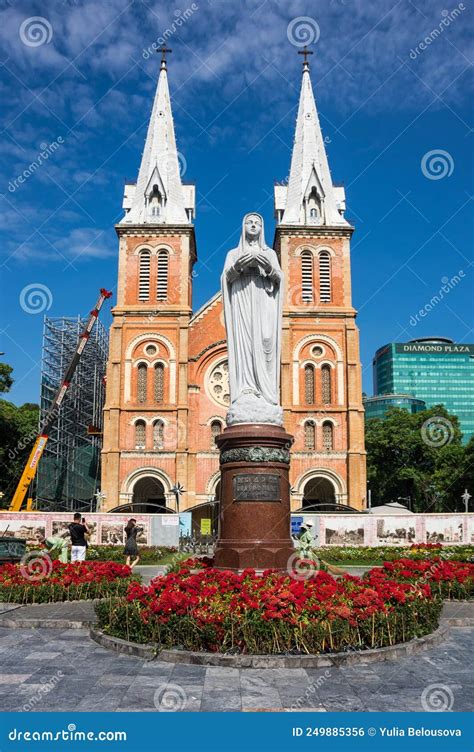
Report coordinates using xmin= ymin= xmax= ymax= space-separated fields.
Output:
xmin=0 ymin=603 xmax=474 ymax=712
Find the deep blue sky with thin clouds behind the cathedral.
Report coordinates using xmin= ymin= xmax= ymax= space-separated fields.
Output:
xmin=0 ymin=0 xmax=474 ymax=404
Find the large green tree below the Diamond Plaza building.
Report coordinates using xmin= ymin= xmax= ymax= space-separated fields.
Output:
xmin=366 ymin=405 xmax=467 ymax=512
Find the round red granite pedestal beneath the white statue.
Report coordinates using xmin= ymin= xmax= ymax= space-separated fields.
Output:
xmin=214 ymin=423 xmax=294 ymax=571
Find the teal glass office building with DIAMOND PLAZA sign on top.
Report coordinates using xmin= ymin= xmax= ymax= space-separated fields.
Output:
xmin=372 ymin=337 xmax=474 ymax=442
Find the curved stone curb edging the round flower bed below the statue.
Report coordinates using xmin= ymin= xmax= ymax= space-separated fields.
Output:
xmin=90 ymin=619 xmax=452 ymax=668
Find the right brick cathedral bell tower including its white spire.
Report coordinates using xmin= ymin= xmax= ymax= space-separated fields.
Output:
xmin=274 ymin=48 xmax=366 ymax=511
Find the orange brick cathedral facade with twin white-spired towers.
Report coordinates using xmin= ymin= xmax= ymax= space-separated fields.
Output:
xmin=102 ymin=55 xmax=366 ymax=516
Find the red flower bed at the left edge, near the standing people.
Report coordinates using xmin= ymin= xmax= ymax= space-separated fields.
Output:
xmin=0 ymin=551 xmax=140 ymax=603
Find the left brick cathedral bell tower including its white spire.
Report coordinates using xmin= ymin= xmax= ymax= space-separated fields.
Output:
xmin=102 ymin=48 xmax=196 ymax=512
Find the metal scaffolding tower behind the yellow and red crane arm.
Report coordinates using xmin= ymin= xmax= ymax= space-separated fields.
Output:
xmin=36 ymin=316 xmax=108 ymax=512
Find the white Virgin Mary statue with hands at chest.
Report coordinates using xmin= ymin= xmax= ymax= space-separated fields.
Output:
xmin=221 ymin=212 xmax=283 ymax=426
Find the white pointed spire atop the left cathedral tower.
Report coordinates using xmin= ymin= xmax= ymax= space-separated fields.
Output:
xmin=120 ymin=47 xmax=194 ymax=225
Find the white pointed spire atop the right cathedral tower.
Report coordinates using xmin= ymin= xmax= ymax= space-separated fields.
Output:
xmin=275 ymin=48 xmax=348 ymax=226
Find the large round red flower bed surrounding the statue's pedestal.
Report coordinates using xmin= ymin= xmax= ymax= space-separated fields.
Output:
xmin=97 ymin=560 xmax=452 ymax=654
